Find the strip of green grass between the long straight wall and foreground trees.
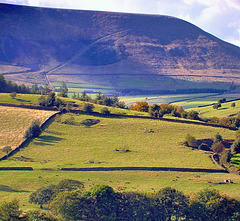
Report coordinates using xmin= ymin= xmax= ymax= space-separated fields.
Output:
xmin=0 ymin=170 xmax=240 ymax=211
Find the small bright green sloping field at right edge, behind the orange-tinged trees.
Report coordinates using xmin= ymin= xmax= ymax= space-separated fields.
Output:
xmin=193 ymin=101 xmax=240 ymax=118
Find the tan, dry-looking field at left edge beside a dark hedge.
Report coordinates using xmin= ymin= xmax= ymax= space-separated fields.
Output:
xmin=0 ymin=106 xmax=56 ymax=156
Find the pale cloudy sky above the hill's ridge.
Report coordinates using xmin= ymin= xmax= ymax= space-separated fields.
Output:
xmin=0 ymin=0 xmax=240 ymax=46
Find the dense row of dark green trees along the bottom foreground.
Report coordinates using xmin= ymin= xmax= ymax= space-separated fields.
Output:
xmin=0 ymin=180 xmax=240 ymax=221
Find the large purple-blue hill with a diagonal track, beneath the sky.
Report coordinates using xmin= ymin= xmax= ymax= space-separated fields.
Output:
xmin=0 ymin=4 xmax=240 ymax=94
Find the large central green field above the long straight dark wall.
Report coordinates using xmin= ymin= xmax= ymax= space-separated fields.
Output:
xmin=0 ymin=114 xmax=234 ymax=169
